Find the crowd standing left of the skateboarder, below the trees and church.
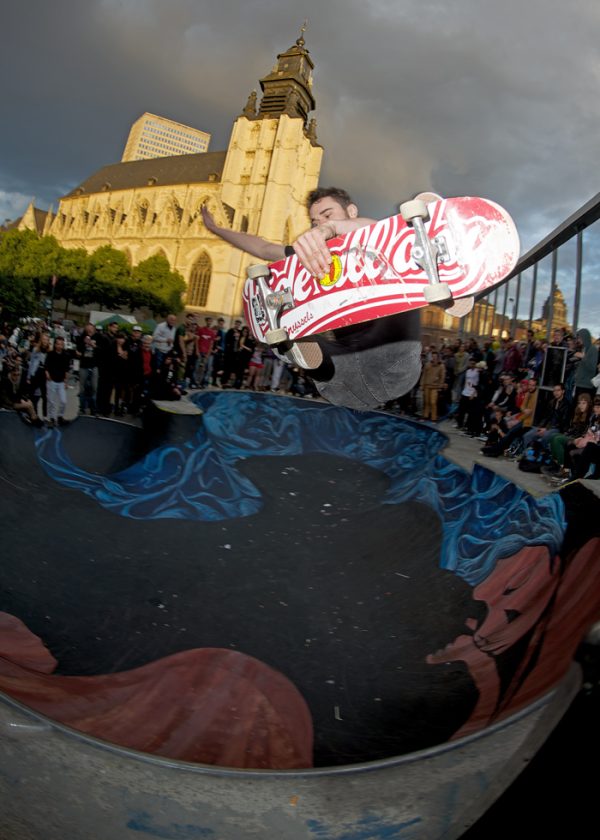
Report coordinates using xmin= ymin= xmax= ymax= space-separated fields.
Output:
xmin=0 ymin=313 xmax=318 ymax=426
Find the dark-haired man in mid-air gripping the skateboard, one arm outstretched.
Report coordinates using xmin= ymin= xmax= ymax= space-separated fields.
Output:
xmin=202 ymin=187 xmax=421 ymax=409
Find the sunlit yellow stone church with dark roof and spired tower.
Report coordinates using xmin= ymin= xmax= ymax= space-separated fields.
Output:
xmin=28 ymin=34 xmax=323 ymax=317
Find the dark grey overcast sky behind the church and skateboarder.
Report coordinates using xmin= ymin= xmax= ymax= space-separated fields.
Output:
xmin=0 ymin=0 xmax=600 ymax=334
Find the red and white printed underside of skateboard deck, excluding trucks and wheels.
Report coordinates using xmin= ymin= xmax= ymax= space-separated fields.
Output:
xmin=244 ymin=197 xmax=519 ymax=340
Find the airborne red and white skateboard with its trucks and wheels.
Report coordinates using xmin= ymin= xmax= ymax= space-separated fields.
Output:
xmin=243 ymin=193 xmax=519 ymax=347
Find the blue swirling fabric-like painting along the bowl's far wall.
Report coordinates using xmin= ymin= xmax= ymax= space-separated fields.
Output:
xmin=36 ymin=392 xmax=566 ymax=586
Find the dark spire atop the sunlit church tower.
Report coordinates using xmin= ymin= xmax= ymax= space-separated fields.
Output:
xmin=258 ymin=26 xmax=315 ymax=128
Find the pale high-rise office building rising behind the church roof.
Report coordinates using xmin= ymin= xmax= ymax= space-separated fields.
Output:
xmin=121 ymin=113 xmax=210 ymax=162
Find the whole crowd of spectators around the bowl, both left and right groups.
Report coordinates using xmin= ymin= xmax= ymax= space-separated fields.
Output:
xmin=0 ymin=313 xmax=600 ymax=482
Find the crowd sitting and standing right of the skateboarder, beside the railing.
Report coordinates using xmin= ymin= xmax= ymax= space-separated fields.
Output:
xmin=404 ymin=329 xmax=600 ymax=484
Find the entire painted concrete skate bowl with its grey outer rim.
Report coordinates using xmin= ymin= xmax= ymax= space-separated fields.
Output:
xmin=0 ymin=392 xmax=600 ymax=840
